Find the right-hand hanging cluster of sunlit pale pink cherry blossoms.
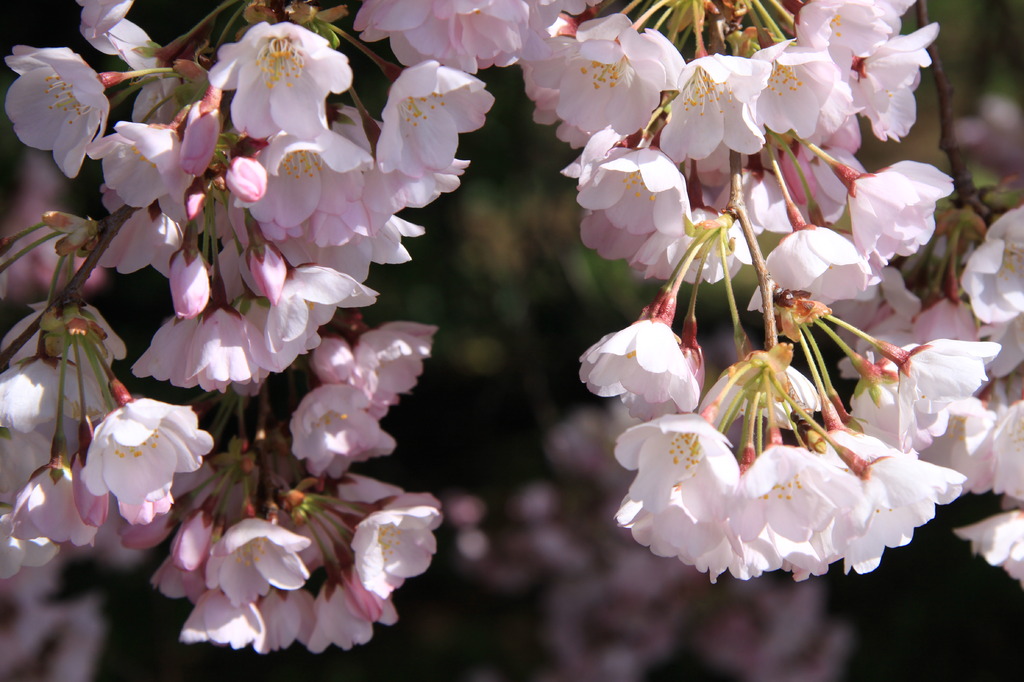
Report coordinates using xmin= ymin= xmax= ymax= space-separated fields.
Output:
xmin=548 ymin=0 xmax=1024 ymax=581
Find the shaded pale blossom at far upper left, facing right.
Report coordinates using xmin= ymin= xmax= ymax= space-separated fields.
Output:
xmin=4 ymin=45 xmax=111 ymax=177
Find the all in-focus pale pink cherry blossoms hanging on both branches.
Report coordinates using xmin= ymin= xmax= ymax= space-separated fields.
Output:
xmin=0 ymin=0 xmax=1024 ymax=663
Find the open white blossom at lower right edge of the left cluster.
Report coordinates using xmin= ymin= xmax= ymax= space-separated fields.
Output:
xmin=352 ymin=494 xmax=441 ymax=599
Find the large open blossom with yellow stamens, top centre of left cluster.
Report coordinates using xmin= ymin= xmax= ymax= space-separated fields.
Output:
xmin=210 ymin=22 xmax=352 ymax=139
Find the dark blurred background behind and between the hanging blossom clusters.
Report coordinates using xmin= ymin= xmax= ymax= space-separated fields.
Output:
xmin=0 ymin=0 xmax=1024 ymax=682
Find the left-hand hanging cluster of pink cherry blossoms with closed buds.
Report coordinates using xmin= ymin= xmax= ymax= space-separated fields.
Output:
xmin=0 ymin=0 xmax=462 ymax=652
